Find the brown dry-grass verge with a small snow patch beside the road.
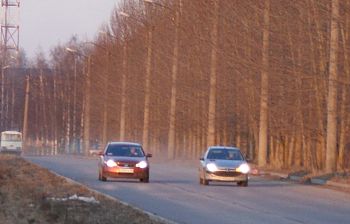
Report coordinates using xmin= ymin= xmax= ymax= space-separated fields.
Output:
xmin=0 ymin=154 xmax=167 ymax=224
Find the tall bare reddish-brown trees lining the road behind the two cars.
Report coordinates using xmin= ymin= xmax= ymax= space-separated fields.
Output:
xmin=3 ymin=0 xmax=350 ymax=172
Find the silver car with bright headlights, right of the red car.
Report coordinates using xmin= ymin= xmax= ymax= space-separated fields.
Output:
xmin=199 ymin=146 xmax=250 ymax=187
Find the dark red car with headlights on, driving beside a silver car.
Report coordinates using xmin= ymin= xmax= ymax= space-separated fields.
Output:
xmin=98 ymin=142 xmax=152 ymax=183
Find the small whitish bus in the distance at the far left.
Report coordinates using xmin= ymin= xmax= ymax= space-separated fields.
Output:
xmin=0 ymin=131 xmax=22 ymax=154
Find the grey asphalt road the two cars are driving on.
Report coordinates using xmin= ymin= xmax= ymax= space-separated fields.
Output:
xmin=25 ymin=156 xmax=350 ymax=224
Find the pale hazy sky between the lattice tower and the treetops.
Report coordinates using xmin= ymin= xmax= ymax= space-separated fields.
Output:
xmin=19 ymin=0 xmax=118 ymax=58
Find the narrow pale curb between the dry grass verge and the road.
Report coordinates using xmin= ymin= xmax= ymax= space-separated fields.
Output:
xmin=26 ymin=159 xmax=179 ymax=224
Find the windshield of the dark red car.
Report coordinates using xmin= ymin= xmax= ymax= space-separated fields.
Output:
xmin=106 ymin=144 xmax=144 ymax=157
